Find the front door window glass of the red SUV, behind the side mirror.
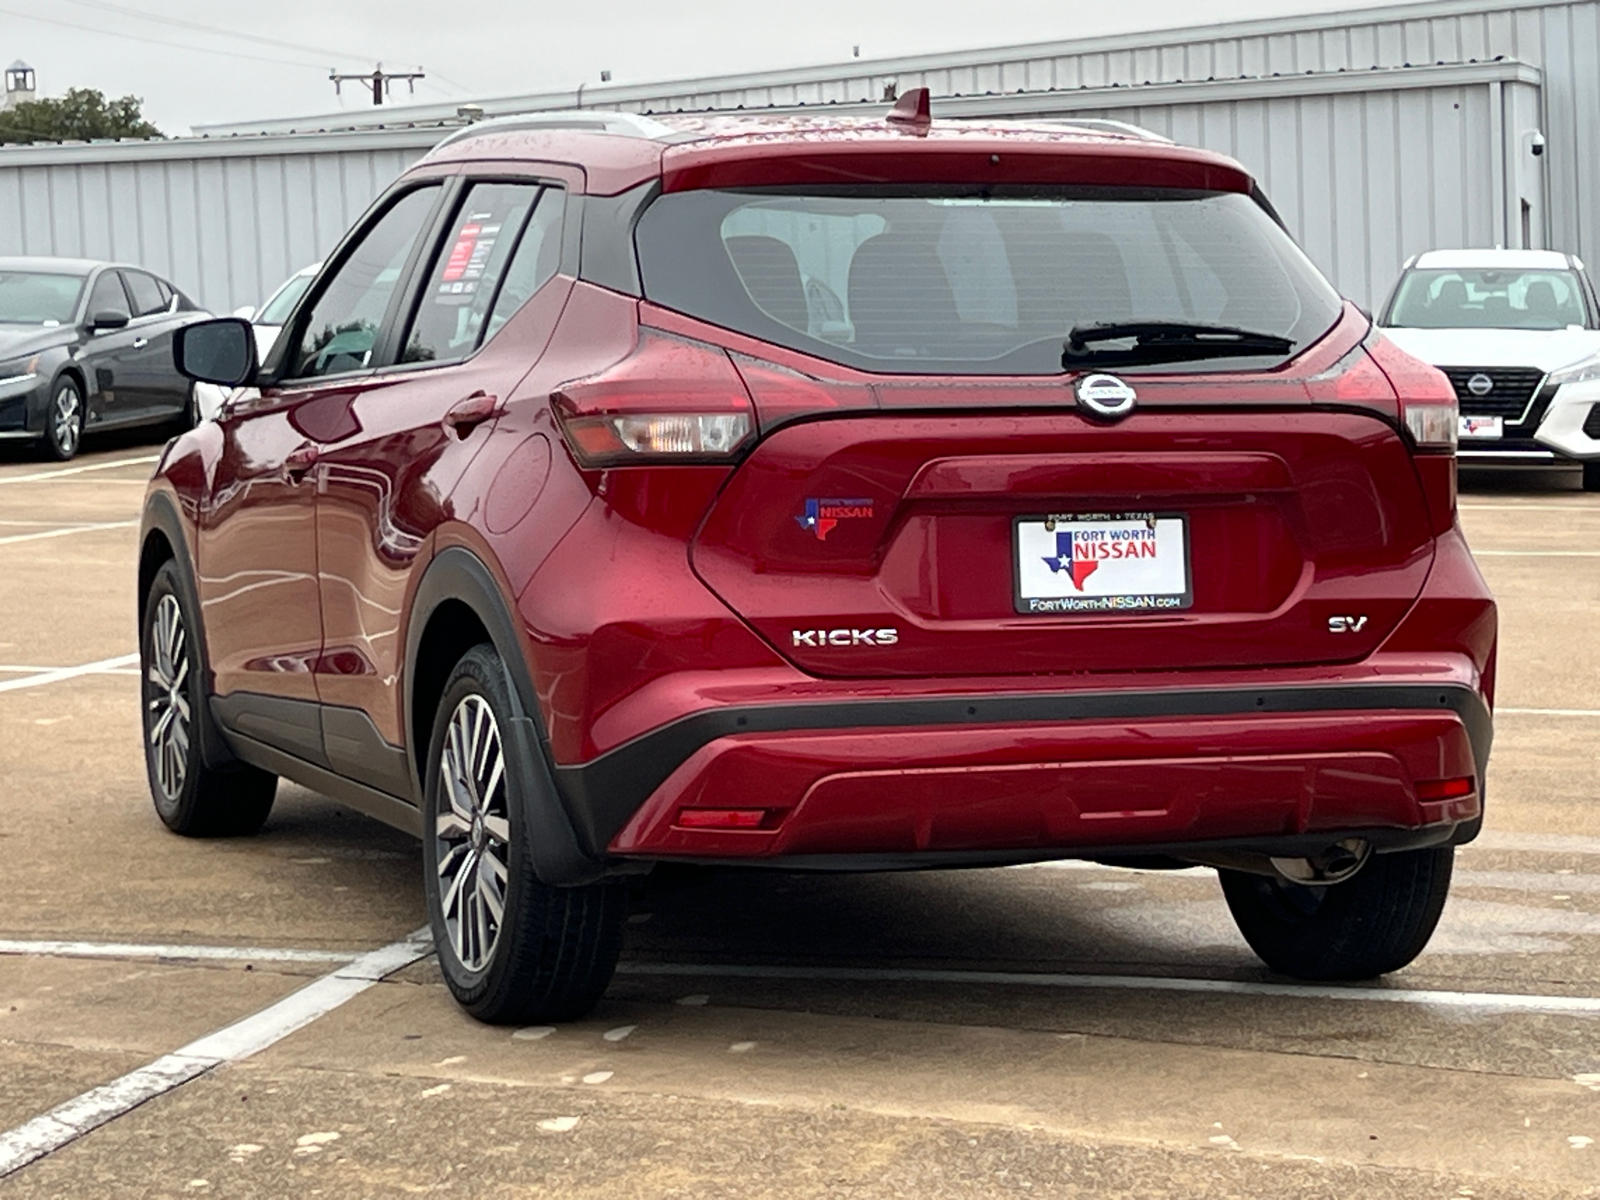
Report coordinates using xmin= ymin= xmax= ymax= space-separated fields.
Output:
xmin=288 ymin=187 xmax=438 ymax=379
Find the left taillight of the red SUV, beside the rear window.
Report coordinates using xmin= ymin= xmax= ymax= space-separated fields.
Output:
xmin=552 ymin=339 xmax=757 ymax=467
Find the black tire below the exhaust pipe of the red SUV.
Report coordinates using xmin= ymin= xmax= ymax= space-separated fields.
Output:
xmin=1218 ymin=846 xmax=1456 ymax=979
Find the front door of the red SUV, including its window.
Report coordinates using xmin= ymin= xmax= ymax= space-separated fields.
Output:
xmin=198 ymin=181 xmax=442 ymax=765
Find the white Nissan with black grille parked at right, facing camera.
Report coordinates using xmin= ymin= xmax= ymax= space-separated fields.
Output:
xmin=1378 ymin=250 xmax=1600 ymax=491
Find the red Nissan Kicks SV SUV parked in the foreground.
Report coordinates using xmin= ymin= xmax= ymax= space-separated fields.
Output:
xmin=139 ymin=96 xmax=1496 ymax=1021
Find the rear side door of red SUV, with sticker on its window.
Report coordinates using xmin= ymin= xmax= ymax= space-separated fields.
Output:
xmin=307 ymin=168 xmax=570 ymax=795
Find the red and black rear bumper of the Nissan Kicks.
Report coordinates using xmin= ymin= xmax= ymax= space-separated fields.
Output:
xmin=557 ymin=680 xmax=1491 ymax=869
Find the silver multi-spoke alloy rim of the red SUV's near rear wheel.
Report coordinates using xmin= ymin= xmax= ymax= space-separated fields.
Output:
xmin=434 ymin=696 xmax=510 ymax=971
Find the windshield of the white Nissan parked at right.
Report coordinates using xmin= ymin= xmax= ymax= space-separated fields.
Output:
xmin=1384 ymin=270 xmax=1590 ymax=330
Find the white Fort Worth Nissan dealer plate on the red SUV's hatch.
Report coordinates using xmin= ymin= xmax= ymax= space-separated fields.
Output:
xmin=1011 ymin=512 xmax=1194 ymax=616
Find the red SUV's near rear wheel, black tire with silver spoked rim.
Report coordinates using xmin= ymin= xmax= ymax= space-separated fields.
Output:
xmin=422 ymin=643 xmax=626 ymax=1024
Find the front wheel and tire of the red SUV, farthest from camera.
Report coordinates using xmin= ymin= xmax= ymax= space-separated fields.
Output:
xmin=139 ymin=562 xmax=278 ymax=837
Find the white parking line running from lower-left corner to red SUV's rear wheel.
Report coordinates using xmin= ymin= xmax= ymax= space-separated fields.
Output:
xmin=0 ymin=930 xmax=434 ymax=1179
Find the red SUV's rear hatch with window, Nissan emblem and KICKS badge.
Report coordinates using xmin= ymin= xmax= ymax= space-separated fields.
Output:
xmin=635 ymin=142 xmax=1454 ymax=677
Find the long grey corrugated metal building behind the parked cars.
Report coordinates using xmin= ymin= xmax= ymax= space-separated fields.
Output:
xmin=0 ymin=0 xmax=1600 ymax=310
